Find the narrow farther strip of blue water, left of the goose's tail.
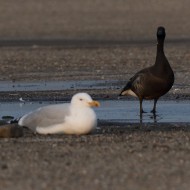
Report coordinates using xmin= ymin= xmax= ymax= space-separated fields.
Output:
xmin=0 ymin=80 xmax=126 ymax=92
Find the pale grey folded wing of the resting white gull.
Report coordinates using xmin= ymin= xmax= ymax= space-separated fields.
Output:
xmin=18 ymin=104 xmax=70 ymax=131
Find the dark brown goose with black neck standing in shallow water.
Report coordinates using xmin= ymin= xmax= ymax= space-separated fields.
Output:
xmin=120 ymin=27 xmax=174 ymax=114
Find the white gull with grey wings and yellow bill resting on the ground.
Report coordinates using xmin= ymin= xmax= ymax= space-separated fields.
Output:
xmin=18 ymin=93 xmax=99 ymax=135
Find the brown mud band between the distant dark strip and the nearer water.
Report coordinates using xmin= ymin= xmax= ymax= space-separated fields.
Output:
xmin=0 ymin=40 xmax=190 ymax=100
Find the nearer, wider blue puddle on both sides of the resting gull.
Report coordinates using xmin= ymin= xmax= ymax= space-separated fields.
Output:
xmin=0 ymin=100 xmax=190 ymax=123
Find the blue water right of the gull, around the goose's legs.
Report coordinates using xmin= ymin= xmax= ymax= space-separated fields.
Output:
xmin=97 ymin=100 xmax=190 ymax=123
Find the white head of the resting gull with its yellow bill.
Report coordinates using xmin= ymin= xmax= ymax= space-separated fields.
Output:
xmin=71 ymin=93 xmax=100 ymax=107
